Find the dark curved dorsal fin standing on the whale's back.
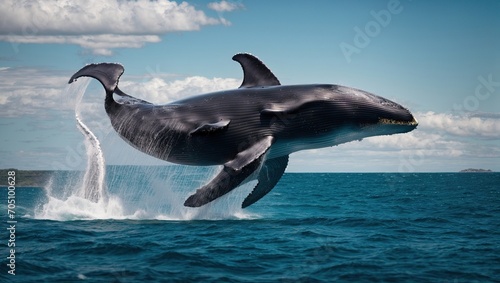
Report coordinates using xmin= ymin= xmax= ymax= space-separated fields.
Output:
xmin=233 ymin=53 xmax=280 ymax=88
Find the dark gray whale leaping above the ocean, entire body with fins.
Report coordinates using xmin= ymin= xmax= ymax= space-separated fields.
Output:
xmin=69 ymin=53 xmax=418 ymax=208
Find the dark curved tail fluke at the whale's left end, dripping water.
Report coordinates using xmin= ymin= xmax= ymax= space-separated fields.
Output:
xmin=68 ymin=63 xmax=124 ymax=94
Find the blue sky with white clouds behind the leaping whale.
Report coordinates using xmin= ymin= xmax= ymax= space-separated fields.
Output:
xmin=0 ymin=0 xmax=500 ymax=172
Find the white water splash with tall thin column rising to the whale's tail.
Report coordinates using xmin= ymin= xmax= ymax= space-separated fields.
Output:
xmin=35 ymin=78 xmax=258 ymax=221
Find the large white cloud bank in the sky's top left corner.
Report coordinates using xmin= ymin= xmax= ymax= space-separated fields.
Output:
xmin=0 ymin=0 xmax=231 ymax=55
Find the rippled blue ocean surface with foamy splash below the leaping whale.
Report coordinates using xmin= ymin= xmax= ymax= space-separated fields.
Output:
xmin=0 ymin=169 xmax=500 ymax=282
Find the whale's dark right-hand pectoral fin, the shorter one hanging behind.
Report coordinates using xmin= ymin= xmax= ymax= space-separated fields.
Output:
xmin=241 ymin=155 xmax=288 ymax=208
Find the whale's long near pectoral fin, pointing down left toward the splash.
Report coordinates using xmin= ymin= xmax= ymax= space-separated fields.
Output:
xmin=184 ymin=136 xmax=273 ymax=207
